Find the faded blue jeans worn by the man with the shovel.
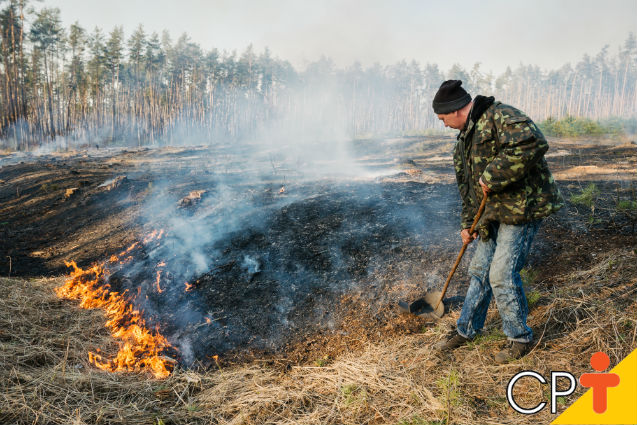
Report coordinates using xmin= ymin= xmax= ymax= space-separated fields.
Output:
xmin=457 ymin=220 xmax=542 ymax=342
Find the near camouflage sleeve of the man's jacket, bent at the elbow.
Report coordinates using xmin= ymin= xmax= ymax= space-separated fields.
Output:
xmin=482 ymin=108 xmax=549 ymax=192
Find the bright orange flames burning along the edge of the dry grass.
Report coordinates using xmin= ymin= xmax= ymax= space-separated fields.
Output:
xmin=55 ymin=247 xmax=174 ymax=378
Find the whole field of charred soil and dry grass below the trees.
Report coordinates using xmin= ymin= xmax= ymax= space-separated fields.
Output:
xmin=0 ymin=137 xmax=637 ymax=423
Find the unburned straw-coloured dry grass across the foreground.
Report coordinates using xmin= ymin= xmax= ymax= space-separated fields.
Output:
xmin=0 ymin=249 xmax=637 ymax=425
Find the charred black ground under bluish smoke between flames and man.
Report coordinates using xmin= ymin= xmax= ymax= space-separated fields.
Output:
xmin=110 ymin=176 xmax=456 ymax=363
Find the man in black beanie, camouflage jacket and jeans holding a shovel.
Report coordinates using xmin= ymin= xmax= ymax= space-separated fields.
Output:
xmin=433 ymin=80 xmax=564 ymax=363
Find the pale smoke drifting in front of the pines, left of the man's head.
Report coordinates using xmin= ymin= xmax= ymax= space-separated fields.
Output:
xmin=0 ymin=51 xmax=448 ymax=152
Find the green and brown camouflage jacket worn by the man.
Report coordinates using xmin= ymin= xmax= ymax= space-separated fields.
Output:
xmin=453 ymin=96 xmax=564 ymax=239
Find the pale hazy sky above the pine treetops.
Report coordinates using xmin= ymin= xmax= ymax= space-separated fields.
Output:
xmin=39 ymin=0 xmax=637 ymax=73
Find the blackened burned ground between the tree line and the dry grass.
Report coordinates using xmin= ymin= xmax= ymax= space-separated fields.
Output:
xmin=0 ymin=138 xmax=637 ymax=365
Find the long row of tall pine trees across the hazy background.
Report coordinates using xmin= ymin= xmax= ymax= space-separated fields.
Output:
xmin=0 ymin=0 xmax=637 ymax=150
